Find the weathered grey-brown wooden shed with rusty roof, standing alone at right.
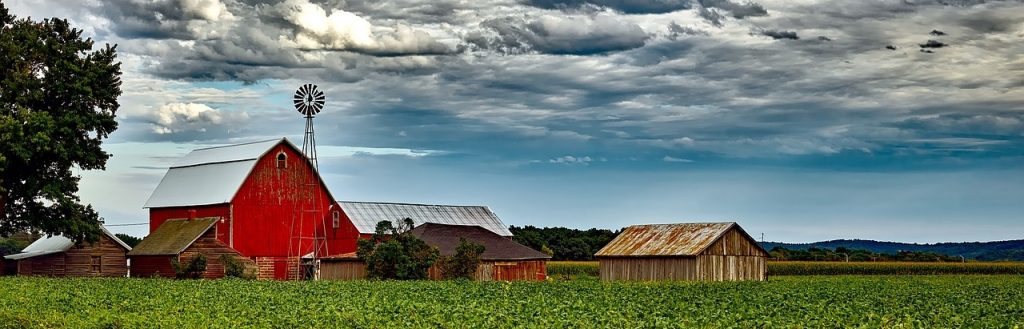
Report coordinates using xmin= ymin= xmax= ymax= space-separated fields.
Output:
xmin=595 ymin=222 xmax=768 ymax=281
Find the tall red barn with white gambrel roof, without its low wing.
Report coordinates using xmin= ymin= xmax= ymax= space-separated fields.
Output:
xmin=137 ymin=138 xmax=358 ymax=280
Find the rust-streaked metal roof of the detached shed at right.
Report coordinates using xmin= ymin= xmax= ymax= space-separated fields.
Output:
xmin=595 ymin=221 xmax=736 ymax=257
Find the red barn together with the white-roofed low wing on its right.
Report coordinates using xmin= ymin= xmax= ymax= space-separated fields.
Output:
xmin=139 ymin=138 xmax=512 ymax=280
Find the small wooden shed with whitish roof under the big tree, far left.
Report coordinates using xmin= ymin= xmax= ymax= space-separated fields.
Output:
xmin=4 ymin=227 xmax=131 ymax=277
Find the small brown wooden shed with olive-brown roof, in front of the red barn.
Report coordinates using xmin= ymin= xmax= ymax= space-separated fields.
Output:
xmin=128 ymin=217 xmax=256 ymax=279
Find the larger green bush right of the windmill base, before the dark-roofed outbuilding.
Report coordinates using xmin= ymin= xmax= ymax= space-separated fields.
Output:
xmin=356 ymin=218 xmax=438 ymax=280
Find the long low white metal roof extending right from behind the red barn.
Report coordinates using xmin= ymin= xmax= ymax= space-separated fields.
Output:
xmin=338 ymin=201 xmax=512 ymax=237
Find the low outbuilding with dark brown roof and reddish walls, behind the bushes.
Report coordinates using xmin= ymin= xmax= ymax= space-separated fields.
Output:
xmin=412 ymin=222 xmax=551 ymax=281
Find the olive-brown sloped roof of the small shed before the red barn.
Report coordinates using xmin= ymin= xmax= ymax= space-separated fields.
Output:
xmin=128 ymin=217 xmax=220 ymax=256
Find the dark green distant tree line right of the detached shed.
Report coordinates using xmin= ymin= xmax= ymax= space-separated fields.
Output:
xmin=769 ymin=246 xmax=961 ymax=261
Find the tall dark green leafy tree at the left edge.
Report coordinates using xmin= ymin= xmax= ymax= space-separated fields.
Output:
xmin=0 ymin=3 xmax=121 ymax=241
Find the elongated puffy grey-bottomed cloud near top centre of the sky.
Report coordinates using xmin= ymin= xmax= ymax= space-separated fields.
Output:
xmin=465 ymin=15 xmax=649 ymax=54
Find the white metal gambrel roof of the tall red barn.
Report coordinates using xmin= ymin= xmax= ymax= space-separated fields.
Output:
xmin=143 ymin=138 xmax=295 ymax=208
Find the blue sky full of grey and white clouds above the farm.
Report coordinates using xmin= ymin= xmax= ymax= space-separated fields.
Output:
xmin=3 ymin=0 xmax=1024 ymax=243
